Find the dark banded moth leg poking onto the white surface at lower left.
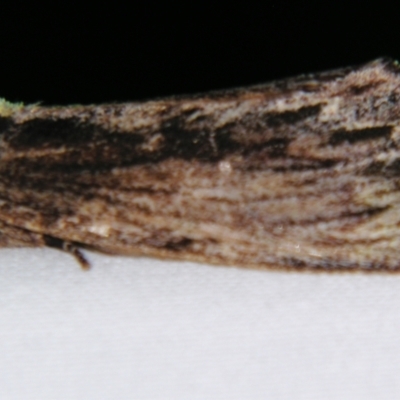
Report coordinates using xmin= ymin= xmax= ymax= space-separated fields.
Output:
xmin=0 ymin=221 xmax=90 ymax=270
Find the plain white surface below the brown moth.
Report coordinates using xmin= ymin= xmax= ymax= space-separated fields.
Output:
xmin=0 ymin=249 xmax=400 ymax=400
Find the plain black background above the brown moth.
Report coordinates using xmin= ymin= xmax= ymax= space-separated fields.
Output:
xmin=0 ymin=1 xmax=400 ymax=104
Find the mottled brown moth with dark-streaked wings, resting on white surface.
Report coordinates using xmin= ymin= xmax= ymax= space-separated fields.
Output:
xmin=0 ymin=59 xmax=400 ymax=271
